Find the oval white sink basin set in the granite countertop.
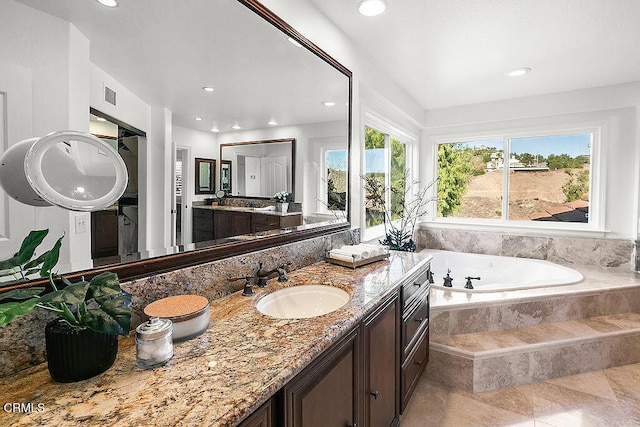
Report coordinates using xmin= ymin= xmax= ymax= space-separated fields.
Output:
xmin=256 ymin=285 xmax=351 ymax=319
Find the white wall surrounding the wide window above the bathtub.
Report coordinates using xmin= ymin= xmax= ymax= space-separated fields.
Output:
xmin=420 ymin=83 xmax=640 ymax=239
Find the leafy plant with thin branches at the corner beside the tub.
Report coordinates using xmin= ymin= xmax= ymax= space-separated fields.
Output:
xmin=361 ymin=169 xmax=436 ymax=252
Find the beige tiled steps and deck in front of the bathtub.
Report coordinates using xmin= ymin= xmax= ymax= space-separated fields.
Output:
xmin=426 ymin=265 xmax=640 ymax=392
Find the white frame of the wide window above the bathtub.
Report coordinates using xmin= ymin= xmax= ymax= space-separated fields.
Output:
xmin=430 ymin=122 xmax=606 ymax=234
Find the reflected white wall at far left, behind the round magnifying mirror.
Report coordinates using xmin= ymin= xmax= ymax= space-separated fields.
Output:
xmin=0 ymin=0 xmax=91 ymax=271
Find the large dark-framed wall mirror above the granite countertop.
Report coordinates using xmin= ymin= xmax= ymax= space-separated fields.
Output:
xmin=0 ymin=0 xmax=351 ymax=288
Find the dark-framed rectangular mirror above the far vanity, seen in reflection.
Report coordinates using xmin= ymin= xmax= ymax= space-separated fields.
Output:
xmin=220 ymin=138 xmax=296 ymax=200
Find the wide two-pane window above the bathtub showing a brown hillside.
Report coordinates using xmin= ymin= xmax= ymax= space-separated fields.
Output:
xmin=437 ymin=131 xmax=596 ymax=223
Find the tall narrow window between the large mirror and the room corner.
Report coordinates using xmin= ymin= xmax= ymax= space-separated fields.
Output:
xmin=364 ymin=126 xmax=407 ymax=232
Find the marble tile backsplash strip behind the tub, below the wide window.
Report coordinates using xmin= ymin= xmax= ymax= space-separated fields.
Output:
xmin=416 ymin=226 xmax=635 ymax=269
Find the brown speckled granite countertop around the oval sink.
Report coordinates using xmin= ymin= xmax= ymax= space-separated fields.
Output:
xmin=0 ymin=252 xmax=429 ymax=426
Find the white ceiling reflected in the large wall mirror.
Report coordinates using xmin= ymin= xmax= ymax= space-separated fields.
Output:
xmin=16 ymin=0 xmax=349 ymax=132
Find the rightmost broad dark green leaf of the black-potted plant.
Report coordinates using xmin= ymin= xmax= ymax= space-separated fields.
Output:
xmin=86 ymin=291 xmax=131 ymax=336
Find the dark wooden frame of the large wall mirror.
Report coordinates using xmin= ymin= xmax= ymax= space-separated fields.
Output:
xmin=2 ymin=0 xmax=353 ymax=292
